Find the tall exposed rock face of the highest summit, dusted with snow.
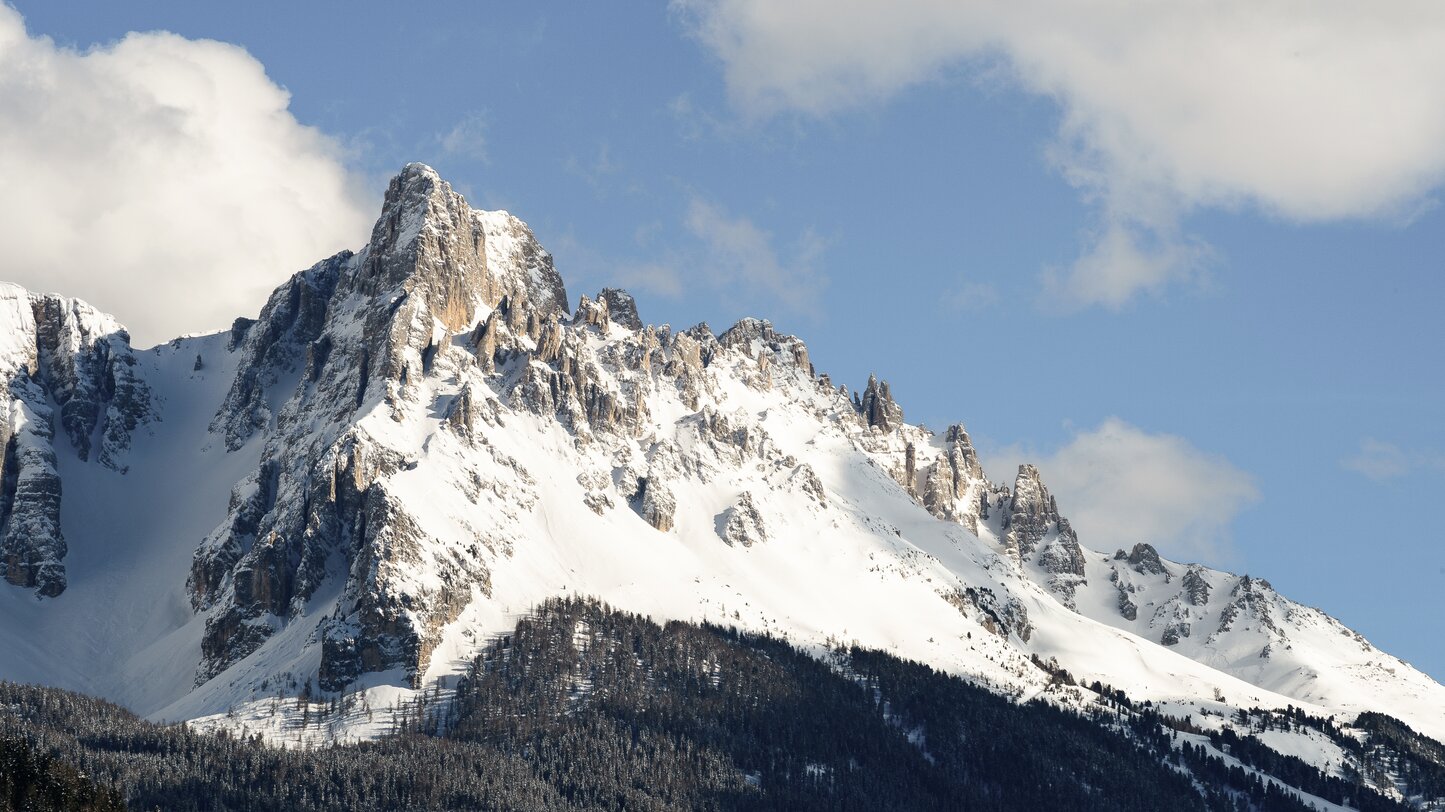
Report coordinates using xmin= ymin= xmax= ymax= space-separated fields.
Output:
xmin=189 ymin=165 xmax=566 ymax=686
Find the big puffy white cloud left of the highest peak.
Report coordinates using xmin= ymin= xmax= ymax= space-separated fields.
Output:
xmin=0 ymin=4 xmax=371 ymax=345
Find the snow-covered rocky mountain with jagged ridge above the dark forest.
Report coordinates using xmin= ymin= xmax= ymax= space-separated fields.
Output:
xmin=0 ymin=165 xmax=1445 ymax=780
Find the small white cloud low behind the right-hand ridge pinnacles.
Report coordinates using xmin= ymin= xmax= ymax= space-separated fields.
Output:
xmin=984 ymin=418 xmax=1259 ymax=563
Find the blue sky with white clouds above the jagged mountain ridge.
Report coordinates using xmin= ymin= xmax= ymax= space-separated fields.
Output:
xmin=0 ymin=0 xmax=1445 ymax=679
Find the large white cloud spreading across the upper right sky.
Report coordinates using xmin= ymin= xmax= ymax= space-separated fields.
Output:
xmin=675 ymin=0 xmax=1445 ymax=306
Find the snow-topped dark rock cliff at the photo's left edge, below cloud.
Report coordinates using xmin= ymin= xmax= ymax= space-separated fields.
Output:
xmin=0 ymin=285 xmax=153 ymax=597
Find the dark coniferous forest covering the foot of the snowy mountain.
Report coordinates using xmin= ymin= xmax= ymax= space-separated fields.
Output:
xmin=0 ymin=600 xmax=1445 ymax=811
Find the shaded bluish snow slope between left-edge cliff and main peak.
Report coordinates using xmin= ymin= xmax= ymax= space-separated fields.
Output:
xmin=0 ymin=325 xmax=256 ymax=711
